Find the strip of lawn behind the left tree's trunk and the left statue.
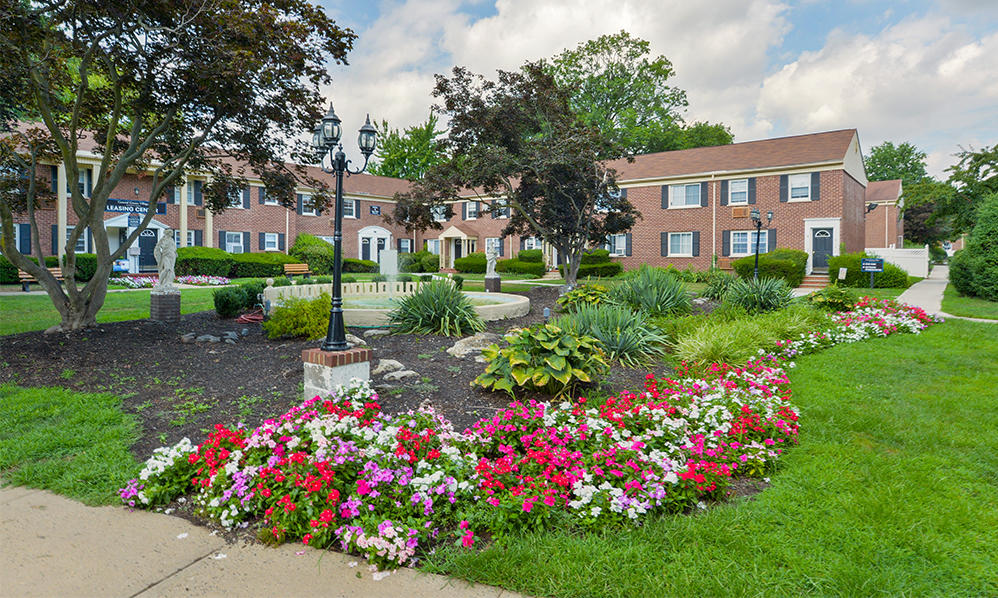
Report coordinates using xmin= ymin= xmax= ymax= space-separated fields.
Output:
xmin=0 ymin=288 xmax=214 ymax=335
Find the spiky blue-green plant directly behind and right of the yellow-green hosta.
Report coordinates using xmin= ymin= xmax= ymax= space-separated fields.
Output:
xmin=552 ymin=304 xmax=667 ymax=367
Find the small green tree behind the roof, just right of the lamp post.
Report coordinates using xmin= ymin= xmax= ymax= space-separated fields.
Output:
xmin=367 ymin=113 xmax=446 ymax=181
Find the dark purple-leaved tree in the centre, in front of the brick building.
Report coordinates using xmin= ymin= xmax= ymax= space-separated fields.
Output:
xmin=391 ymin=63 xmax=639 ymax=285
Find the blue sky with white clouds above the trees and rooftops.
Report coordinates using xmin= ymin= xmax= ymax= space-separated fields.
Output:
xmin=322 ymin=0 xmax=998 ymax=176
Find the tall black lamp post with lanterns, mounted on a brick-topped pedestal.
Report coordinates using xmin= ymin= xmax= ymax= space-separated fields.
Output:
xmin=312 ymin=104 xmax=377 ymax=351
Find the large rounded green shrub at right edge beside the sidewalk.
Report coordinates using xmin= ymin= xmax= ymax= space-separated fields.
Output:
xmin=949 ymin=193 xmax=998 ymax=301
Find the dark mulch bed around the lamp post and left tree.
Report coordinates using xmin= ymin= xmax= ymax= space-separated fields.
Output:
xmin=0 ymin=287 xmax=662 ymax=460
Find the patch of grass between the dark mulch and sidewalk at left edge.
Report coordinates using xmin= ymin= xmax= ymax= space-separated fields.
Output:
xmin=0 ymin=384 xmax=141 ymax=505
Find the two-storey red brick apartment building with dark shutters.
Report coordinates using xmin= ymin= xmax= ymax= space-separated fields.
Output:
xmin=7 ymin=129 xmax=884 ymax=272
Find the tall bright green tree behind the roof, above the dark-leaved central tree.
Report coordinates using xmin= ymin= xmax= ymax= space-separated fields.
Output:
xmin=545 ymin=31 xmax=733 ymax=154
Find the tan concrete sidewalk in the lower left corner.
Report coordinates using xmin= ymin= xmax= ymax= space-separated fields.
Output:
xmin=0 ymin=487 xmax=517 ymax=598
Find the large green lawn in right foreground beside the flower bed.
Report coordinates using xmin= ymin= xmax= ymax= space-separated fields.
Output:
xmin=430 ymin=321 xmax=998 ymax=597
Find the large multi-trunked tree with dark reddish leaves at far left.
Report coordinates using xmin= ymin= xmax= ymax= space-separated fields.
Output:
xmin=0 ymin=0 xmax=355 ymax=330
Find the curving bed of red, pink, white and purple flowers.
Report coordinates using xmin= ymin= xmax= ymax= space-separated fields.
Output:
xmin=121 ymin=300 xmax=933 ymax=568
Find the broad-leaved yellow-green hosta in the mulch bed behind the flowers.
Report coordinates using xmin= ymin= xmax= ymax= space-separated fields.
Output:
xmin=474 ymin=324 xmax=610 ymax=396
